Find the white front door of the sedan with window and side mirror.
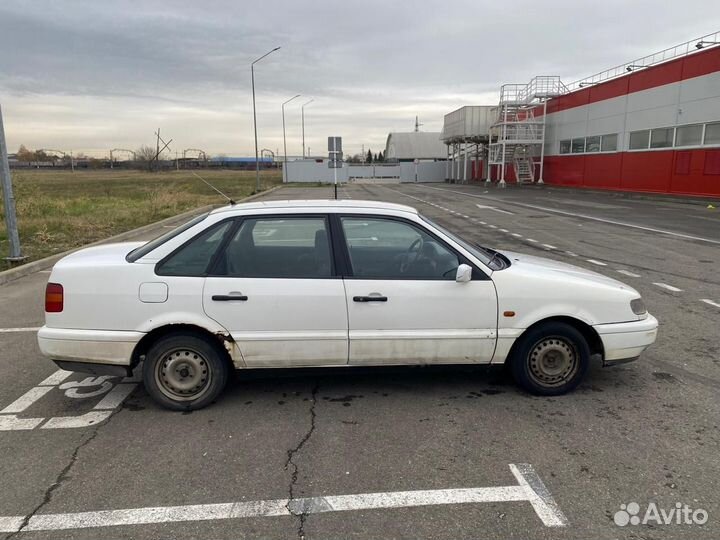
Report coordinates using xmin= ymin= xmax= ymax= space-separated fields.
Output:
xmin=340 ymin=215 xmax=497 ymax=364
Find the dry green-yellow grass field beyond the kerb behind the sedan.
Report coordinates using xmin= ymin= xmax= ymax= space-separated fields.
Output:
xmin=0 ymin=170 xmax=282 ymax=264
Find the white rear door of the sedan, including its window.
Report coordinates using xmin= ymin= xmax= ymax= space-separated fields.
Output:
xmin=203 ymin=215 xmax=348 ymax=367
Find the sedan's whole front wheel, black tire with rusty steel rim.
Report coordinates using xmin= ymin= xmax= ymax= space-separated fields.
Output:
xmin=510 ymin=322 xmax=590 ymax=396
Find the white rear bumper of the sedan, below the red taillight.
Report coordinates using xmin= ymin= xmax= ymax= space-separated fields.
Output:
xmin=38 ymin=326 xmax=145 ymax=366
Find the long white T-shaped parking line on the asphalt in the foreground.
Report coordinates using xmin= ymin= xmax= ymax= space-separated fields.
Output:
xmin=0 ymin=463 xmax=568 ymax=533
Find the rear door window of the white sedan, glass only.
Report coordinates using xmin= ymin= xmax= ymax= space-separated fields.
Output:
xmin=221 ymin=217 xmax=333 ymax=278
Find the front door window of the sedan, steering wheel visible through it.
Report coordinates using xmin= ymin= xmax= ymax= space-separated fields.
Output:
xmin=341 ymin=217 xmax=460 ymax=280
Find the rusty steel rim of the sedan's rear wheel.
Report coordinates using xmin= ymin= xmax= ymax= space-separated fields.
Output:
xmin=155 ymin=347 xmax=212 ymax=401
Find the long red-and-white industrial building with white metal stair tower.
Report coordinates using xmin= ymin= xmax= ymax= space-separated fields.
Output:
xmin=449 ymin=33 xmax=720 ymax=196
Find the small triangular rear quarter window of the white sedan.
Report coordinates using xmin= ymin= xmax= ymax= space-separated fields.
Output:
xmin=156 ymin=220 xmax=233 ymax=276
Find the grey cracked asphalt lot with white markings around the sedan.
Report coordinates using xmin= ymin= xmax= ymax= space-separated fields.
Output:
xmin=0 ymin=184 xmax=720 ymax=539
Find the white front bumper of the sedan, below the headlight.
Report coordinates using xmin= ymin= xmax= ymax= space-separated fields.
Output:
xmin=593 ymin=314 xmax=658 ymax=366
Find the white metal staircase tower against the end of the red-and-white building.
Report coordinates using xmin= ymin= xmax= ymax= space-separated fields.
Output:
xmin=488 ymin=76 xmax=568 ymax=187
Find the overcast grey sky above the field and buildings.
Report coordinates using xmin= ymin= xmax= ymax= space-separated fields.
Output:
xmin=0 ymin=0 xmax=720 ymax=156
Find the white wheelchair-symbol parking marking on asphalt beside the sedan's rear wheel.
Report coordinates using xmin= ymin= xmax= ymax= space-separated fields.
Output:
xmin=0 ymin=369 xmax=137 ymax=431
